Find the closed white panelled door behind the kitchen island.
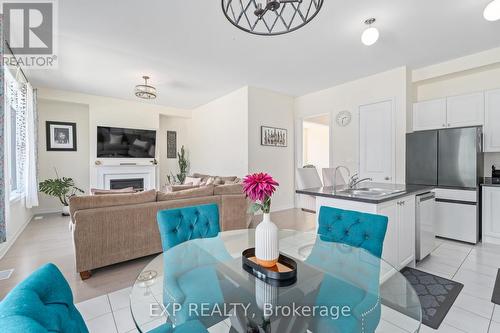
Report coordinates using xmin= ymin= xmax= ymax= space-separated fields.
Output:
xmin=359 ymin=101 xmax=395 ymax=183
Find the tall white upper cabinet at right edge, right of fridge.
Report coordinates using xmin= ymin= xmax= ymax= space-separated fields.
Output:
xmin=484 ymin=89 xmax=500 ymax=153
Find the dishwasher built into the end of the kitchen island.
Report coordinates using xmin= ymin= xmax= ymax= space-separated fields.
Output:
xmin=415 ymin=192 xmax=436 ymax=260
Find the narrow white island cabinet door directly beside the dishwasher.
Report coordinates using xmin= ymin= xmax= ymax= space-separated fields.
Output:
xmin=398 ymin=197 xmax=415 ymax=267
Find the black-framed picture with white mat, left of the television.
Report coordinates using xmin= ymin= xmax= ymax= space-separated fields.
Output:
xmin=45 ymin=121 xmax=76 ymax=151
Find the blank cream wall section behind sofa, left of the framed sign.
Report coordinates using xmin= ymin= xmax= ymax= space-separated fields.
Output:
xmin=189 ymin=87 xmax=248 ymax=177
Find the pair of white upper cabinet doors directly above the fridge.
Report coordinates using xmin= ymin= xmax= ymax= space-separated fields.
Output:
xmin=413 ymin=92 xmax=485 ymax=131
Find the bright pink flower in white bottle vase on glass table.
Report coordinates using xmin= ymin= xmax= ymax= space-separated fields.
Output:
xmin=243 ymin=173 xmax=279 ymax=267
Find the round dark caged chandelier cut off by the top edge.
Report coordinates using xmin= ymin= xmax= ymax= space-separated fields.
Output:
xmin=222 ymin=0 xmax=324 ymax=36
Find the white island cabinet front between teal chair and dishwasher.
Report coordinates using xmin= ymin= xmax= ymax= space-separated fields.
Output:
xmin=378 ymin=196 xmax=415 ymax=269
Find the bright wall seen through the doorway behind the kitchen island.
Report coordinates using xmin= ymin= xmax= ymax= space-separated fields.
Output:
xmin=302 ymin=121 xmax=330 ymax=170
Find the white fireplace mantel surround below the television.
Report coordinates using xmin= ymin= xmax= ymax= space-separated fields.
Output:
xmin=91 ymin=164 xmax=157 ymax=191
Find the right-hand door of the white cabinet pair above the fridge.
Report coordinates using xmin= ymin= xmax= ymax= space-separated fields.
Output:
xmin=446 ymin=92 xmax=484 ymax=127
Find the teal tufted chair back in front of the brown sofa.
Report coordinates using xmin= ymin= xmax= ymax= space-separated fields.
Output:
xmin=157 ymin=204 xmax=220 ymax=251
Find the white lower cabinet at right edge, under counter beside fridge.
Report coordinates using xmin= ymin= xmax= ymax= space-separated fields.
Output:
xmin=482 ymin=186 xmax=500 ymax=244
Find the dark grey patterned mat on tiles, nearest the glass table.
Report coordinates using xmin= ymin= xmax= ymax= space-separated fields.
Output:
xmin=382 ymin=267 xmax=464 ymax=329
